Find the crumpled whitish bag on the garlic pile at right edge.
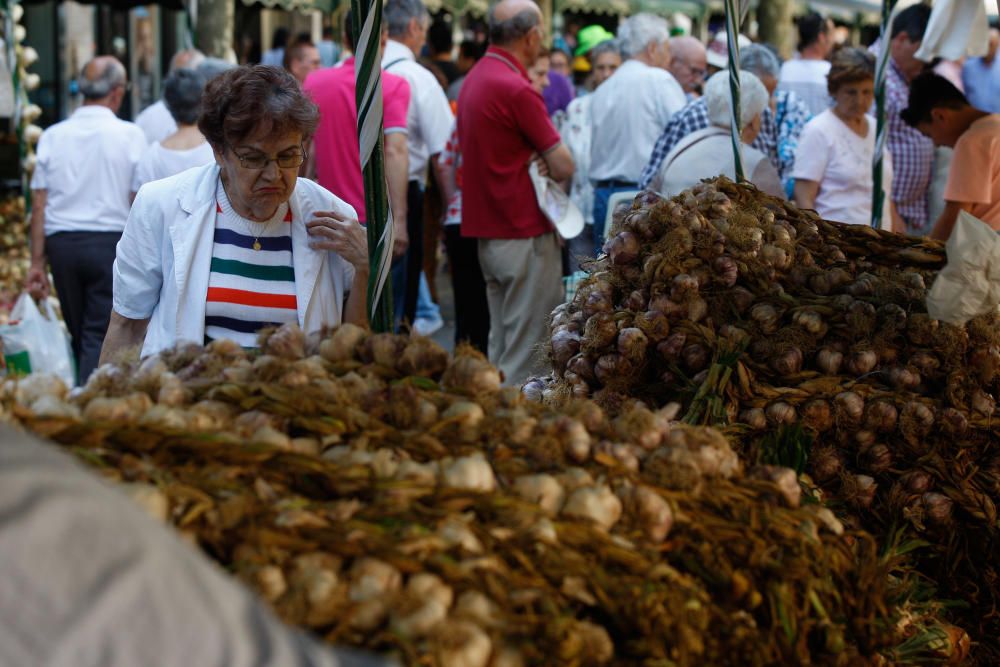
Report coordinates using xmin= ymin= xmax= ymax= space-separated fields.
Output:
xmin=927 ymin=211 xmax=1000 ymax=326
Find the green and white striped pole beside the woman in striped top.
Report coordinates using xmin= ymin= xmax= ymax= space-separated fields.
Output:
xmin=351 ymin=0 xmax=394 ymax=333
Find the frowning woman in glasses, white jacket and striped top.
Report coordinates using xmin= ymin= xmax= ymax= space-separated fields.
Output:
xmin=101 ymin=65 xmax=368 ymax=363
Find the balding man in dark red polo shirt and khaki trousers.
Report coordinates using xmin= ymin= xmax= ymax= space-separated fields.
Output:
xmin=458 ymin=0 xmax=573 ymax=385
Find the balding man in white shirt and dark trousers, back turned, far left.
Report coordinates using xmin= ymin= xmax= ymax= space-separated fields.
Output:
xmin=27 ymin=56 xmax=146 ymax=382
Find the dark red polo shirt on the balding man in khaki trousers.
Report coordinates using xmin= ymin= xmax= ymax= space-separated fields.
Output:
xmin=458 ymin=46 xmax=562 ymax=239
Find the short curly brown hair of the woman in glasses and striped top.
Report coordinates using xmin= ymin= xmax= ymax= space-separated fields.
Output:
xmin=198 ymin=65 xmax=319 ymax=151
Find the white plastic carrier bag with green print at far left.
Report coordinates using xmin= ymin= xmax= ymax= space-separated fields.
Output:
xmin=0 ymin=292 xmax=76 ymax=387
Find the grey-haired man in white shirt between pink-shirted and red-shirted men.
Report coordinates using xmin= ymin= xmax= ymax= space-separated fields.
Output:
xmin=382 ymin=0 xmax=454 ymax=334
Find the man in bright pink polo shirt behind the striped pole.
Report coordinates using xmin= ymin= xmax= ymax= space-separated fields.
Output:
xmin=302 ymin=12 xmax=419 ymax=258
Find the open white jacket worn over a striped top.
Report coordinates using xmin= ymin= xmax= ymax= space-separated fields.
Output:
xmin=114 ymin=163 xmax=357 ymax=357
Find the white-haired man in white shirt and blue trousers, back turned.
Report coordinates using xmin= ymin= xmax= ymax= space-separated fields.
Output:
xmin=590 ymin=14 xmax=687 ymax=248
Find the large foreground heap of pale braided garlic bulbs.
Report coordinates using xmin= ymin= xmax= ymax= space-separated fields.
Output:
xmin=0 ymin=326 xmax=967 ymax=667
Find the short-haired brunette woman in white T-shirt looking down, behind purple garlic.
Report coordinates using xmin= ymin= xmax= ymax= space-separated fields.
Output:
xmin=792 ymin=48 xmax=902 ymax=231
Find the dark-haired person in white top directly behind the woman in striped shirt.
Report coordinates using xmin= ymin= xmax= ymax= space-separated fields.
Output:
xmin=132 ymin=69 xmax=215 ymax=192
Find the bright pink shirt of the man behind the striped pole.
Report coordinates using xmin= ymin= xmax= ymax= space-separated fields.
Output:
xmin=302 ymin=58 xmax=410 ymax=222
